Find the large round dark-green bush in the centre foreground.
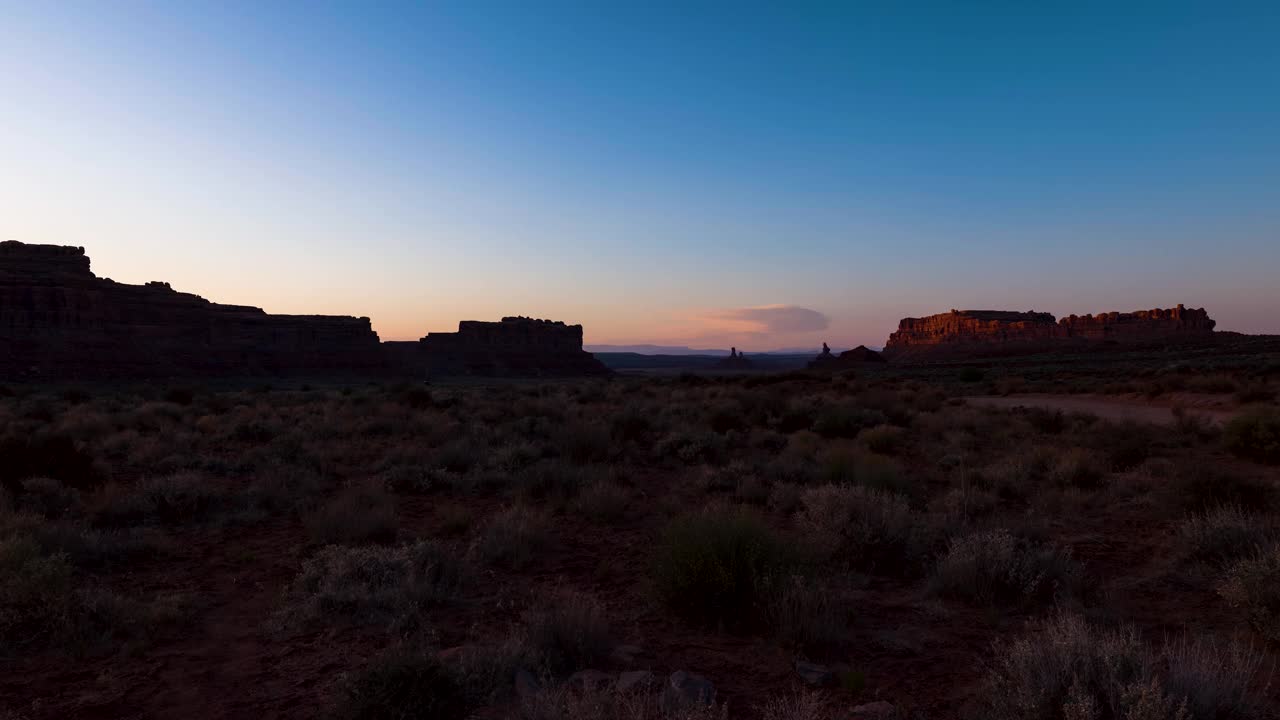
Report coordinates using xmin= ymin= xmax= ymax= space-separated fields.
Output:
xmin=652 ymin=510 xmax=792 ymax=625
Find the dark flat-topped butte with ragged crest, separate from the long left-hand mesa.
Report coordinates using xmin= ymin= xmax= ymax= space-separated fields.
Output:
xmin=384 ymin=316 xmax=611 ymax=377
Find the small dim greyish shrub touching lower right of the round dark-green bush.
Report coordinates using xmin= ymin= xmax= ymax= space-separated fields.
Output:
xmin=762 ymin=575 xmax=849 ymax=650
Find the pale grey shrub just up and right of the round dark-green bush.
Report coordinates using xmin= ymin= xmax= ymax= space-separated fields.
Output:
xmin=797 ymin=484 xmax=919 ymax=571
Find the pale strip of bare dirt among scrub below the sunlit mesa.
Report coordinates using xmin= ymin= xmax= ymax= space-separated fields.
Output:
xmin=965 ymin=393 xmax=1236 ymax=425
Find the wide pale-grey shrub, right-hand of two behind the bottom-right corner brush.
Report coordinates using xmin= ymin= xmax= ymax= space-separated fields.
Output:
xmin=929 ymin=530 xmax=1083 ymax=606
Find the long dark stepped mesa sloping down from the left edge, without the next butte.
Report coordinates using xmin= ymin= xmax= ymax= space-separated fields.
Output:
xmin=0 ymin=241 xmax=384 ymax=378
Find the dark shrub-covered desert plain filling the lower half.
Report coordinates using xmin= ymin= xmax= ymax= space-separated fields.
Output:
xmin=0 ymin=354 xmax=1280 ymax=720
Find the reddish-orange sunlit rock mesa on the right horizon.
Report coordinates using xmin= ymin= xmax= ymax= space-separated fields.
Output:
xmin=884 ymin=305 xmax=1215 ymax=360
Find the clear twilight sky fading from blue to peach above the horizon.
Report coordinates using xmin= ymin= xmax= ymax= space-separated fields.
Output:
xmin=0 ymin=0 xmax=1280 ymax=350
